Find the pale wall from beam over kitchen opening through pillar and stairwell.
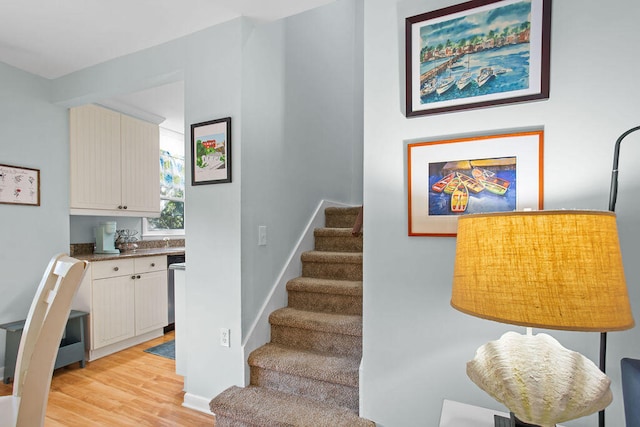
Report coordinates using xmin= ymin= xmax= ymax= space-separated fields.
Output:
xmin=46 ymin=0 xmax=362 ymax=409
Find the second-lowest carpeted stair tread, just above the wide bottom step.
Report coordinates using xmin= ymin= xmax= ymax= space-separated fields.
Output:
xmin=249 ymin=343 xmax=360 ymax=387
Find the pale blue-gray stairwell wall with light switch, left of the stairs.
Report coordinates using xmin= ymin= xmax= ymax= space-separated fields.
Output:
xmin=242 ymin=0 xmax=363 ymax=334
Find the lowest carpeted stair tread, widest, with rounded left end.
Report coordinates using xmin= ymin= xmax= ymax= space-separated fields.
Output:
xmin=209 ymin=386 xmax=375 ymax=427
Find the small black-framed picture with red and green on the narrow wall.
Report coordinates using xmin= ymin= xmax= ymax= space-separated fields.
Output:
xmin=191 ymin=117 xmax=231 ymax=185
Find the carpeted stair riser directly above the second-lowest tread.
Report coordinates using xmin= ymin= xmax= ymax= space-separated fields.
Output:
xmin=271 ymin=325 xmax=362 ymax=359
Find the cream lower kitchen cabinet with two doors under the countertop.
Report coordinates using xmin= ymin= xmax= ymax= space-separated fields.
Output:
xmin=74 ymin=256 xmax=168 ymax=360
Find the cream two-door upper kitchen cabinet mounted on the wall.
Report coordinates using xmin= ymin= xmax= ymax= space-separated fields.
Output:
xmin=69 ymin=105 xmax=160 ymax=216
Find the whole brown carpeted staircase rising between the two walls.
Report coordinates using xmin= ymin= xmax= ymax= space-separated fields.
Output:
xmin=209 ymin=207 xmax=375 ymax=427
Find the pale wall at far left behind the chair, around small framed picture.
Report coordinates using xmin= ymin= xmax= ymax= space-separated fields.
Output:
xmin=0 ymin=63 xmax=69 ymax=367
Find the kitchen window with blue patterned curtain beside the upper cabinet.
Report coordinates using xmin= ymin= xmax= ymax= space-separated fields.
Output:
xmin=142 ymin=128 xmax=185 ymax=236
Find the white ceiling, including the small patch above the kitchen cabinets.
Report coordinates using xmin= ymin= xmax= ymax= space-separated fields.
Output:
xmin=0 ymin=0 xmax=334 ymax=133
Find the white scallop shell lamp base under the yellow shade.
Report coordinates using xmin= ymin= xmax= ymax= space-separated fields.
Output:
xmin=467 ymin=332 xmax=613 ymax=427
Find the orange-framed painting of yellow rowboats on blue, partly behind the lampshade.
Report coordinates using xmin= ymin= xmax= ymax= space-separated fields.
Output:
xmin=407 ymin=130 xmax=544 ymax=237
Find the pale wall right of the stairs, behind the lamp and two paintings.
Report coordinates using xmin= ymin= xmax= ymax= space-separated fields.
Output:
xmin=360 ymin=0 xmax=640 ymax=427
